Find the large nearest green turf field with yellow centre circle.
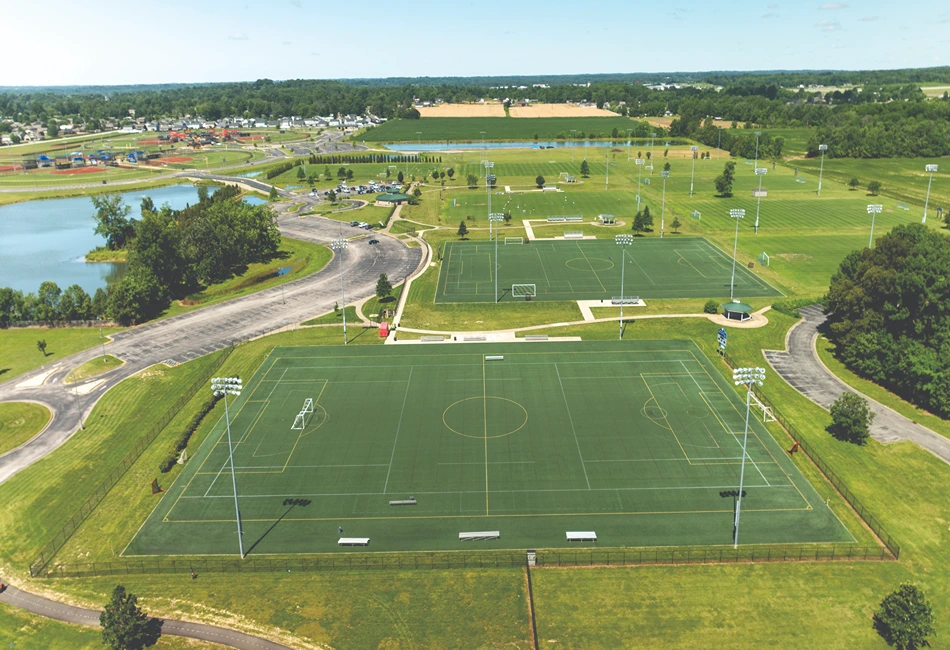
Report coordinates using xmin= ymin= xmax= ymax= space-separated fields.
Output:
xmin=123 ymin=340 xmax=854 ymax=556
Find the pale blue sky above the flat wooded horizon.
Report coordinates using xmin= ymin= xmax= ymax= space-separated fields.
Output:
xmin=9 ymin=0 xmax=950 ymax=85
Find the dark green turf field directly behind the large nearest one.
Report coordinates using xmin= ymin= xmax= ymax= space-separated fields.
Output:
xmin=435 ymin=236 xmax=782 ymax=302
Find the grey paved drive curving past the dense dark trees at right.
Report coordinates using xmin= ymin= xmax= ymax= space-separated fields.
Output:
xmin=765 ymin=305 xmax=950 ymax=463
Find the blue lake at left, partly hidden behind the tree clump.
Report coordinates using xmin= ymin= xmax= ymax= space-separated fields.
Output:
xmin=0 ymin=185 xmax=198 ymax=295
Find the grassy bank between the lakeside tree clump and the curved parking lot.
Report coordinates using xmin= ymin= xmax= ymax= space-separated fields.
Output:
xmin=162 ymin=237 xmax=333 ymax=318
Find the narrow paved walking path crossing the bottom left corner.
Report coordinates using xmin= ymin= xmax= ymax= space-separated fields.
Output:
xmin=0 ymin=585 xmax=289 ymax=650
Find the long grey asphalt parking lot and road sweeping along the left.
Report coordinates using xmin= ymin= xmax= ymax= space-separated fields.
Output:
xmin=0 ymin=215 xmax=422 ymax=483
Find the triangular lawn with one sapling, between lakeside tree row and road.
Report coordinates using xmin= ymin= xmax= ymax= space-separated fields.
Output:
xmin=0 ymin=327 xmax=121 ymax=381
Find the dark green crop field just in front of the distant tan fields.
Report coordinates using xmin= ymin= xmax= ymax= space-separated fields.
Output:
xmin=355 ymin=115 xmax=639 ymax=143
